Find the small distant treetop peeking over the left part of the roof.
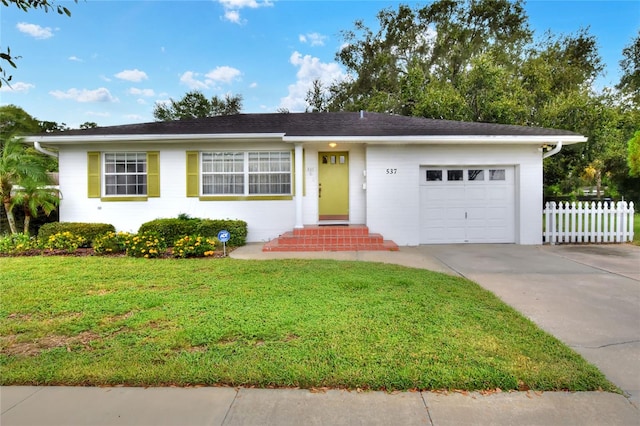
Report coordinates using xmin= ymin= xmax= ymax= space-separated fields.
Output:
xmin=153 ymin=90 xmax=242 ymax=121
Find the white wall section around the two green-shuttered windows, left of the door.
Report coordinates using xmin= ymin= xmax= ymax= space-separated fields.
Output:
xmin=59 ymin=144 xmax=295 ymax=242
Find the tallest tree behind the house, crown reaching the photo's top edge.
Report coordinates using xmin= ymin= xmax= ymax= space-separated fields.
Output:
xmin=329 ymin=0 xmax=531 ymax=115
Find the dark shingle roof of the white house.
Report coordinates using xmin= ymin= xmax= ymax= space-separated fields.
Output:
xmin=47 ymin=112 xmax=579 ymax=137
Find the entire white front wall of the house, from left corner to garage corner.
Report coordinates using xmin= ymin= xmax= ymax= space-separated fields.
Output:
xmin=59 ymin=142 xmax=542 ymax=245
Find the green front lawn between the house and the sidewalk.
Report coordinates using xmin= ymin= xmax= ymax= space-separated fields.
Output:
xmin=0 ymin=257 xmax=616 ymax=391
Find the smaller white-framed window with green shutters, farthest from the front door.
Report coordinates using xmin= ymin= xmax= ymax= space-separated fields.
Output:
xmin=104 ymin=152 xmax=147 ymax=196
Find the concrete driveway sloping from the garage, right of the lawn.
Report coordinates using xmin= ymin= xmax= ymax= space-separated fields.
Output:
xmin=420 ymin=245 xmax=640 ymax=406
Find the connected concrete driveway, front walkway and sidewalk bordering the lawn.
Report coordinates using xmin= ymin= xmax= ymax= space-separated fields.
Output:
xmin=0 ymin=244 xmax=640 ymax=426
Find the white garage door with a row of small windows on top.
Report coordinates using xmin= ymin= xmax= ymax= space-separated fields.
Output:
xmin=420 ymin=166 xmax=515 ymax=244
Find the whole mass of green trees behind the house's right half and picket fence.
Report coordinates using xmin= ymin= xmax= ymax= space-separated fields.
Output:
xmin=306 ymin=0 xmax=640 ymax=203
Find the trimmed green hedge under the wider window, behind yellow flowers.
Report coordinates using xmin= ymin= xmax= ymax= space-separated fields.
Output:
xmin=138 ymin=218 xmax=247 ymax=247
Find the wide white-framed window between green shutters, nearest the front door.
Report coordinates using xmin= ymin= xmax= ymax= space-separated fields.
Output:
xmin=201 ymin=151 xmax=292 ymax=195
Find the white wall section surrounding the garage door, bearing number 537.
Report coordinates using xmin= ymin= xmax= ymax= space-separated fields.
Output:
xmin=366 ymin=145 xmax=542 ymax=246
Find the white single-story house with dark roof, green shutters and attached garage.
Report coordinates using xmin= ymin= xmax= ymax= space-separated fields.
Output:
xmin=27 ymin=112 xmax=586 ymax=246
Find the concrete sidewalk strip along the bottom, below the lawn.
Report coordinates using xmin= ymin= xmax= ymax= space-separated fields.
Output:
xmin=0 ymin=386 xmax=639 ymax=426
